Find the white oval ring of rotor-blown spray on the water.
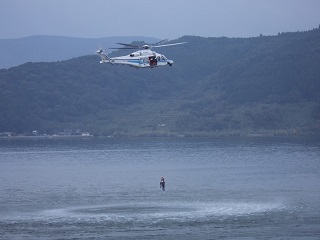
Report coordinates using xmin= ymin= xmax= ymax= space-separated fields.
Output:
xmin=7 ymin=202 xmax=286 ymax=224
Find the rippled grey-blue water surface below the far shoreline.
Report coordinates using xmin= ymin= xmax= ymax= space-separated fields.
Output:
xmin=0 ymin=137 xmax=320 ymax=240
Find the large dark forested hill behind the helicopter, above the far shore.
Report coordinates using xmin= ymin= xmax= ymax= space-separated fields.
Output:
xmin=0 ymin=29 xmax=320 ymax=136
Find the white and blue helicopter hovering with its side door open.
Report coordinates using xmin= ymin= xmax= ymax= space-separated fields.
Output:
xmin=96 ymin=42 xmax=186 ymax=68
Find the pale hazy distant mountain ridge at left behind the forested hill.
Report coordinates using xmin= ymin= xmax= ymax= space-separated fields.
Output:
xmin=0 ymin=35 xmax=160 ymax=69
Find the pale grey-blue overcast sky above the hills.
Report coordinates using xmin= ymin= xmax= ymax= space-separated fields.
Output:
xmin=0 ymin=0 xmax=320 ymax=39
